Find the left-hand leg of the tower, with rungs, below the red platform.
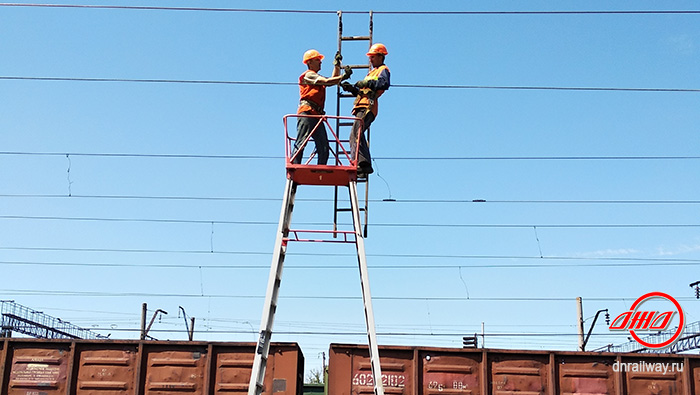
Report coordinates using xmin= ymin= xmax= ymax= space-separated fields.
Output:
xmin=248 ymin=179 xmax=297 ymax=395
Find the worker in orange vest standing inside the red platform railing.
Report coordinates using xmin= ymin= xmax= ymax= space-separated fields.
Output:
xmin=292 ymin=49 xmax=352 ymax=165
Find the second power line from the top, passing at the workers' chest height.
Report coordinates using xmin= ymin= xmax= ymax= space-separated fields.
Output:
xmin=0 ymin=76 xmax=700 ymax=93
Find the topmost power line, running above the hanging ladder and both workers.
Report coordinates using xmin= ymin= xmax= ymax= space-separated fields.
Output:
xmin=0 ymin=3 xmax=700 ymax=15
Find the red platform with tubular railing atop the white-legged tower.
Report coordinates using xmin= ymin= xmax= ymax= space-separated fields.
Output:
xmin=283 ymin=114 xmax=362 ymax=186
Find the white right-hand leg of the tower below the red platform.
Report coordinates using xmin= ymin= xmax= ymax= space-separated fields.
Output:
xmin=348 ymin=181 xmax=384 ymax=395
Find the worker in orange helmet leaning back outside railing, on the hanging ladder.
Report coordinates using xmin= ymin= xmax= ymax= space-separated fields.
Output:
xmin=341 ymin=43 xmax=391 ymax=177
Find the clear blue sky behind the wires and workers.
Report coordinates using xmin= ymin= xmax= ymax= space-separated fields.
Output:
xmin=0 ymin=1 xmax=700 ymax=378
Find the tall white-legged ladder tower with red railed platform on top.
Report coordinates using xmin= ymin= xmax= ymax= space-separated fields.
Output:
xmin=248 ymin=114 xmax=384 ymax=395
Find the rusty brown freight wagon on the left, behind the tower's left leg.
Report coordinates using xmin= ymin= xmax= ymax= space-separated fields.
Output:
xmin=0 ymin=338 xmax=304 ymax=395
